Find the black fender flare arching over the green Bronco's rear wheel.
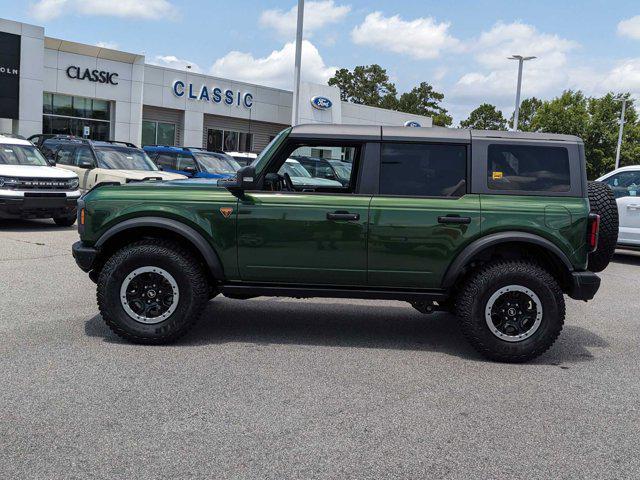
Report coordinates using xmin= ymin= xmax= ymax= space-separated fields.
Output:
xmin=442 ymin=231 xmax=574 ymax=288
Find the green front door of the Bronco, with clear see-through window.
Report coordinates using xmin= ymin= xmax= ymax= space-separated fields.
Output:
xmin=237 ymin=145 xmax=371 ymax=286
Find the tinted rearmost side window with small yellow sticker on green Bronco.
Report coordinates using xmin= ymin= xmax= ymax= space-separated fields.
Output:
xmin=487 ymin=144 xmax=571 ymax=192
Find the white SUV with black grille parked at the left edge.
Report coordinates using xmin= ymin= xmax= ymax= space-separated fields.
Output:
xmin=0 ymin=134 xmax=80 ymax=227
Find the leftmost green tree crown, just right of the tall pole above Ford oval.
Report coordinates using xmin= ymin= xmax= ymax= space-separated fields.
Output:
xmin=329 ymin=64 xmax=397 ymax=107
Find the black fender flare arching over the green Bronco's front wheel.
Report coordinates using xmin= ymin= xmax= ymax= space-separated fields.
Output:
xmin=95 ymin=217 xmax=224 ymax=280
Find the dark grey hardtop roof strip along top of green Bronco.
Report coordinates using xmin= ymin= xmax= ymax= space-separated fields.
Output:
xmin=290 ymin=124 xmax=582 ymax=143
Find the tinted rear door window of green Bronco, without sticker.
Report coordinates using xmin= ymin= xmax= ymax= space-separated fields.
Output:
xmin=380 ymin=143 xmax=467 ymax=197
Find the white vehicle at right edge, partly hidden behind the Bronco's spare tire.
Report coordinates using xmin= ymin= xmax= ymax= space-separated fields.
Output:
xmin=598 ymin=165 xmax=640 ymax=247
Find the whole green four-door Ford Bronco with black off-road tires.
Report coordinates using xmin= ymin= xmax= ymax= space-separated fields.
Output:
xmin=73 ymin=125 xmax=618 ymax=362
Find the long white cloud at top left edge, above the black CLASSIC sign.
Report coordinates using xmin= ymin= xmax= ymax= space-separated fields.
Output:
xmin=31 ymin=0 xmax=176 ymax=21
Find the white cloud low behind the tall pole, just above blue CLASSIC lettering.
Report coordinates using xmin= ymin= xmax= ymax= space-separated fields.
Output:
xmin=210 ymin=40 xmax=336 ymax=88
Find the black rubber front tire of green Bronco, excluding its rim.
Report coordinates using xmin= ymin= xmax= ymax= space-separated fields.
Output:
xmin=97 ymin=240 xmax=210 ymax=344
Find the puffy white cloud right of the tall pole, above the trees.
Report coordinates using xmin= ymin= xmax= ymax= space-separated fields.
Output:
xmin=351 ymin=12 xmax=461 ymax=59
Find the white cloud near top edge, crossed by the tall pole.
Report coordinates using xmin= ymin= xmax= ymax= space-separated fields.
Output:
xmin=260 ymin=0 xmax=351 ymax=38
